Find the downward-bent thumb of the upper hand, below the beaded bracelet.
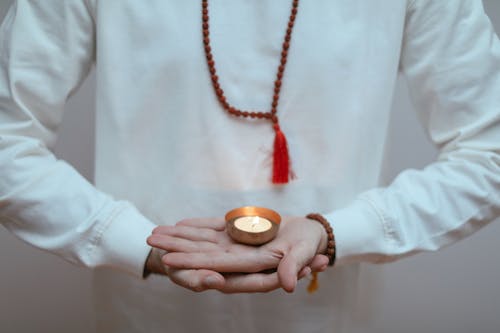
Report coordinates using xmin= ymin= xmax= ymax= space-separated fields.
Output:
xmin=278 ymin=242 xmax=314 ymax=293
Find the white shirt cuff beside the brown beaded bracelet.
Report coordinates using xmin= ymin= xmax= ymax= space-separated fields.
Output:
xmin=324 ymin=199 xmax=390 ymax=266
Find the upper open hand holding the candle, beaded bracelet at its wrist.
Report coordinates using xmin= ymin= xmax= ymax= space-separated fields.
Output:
xmin=148 ymin=217 xmax=328 ymax=292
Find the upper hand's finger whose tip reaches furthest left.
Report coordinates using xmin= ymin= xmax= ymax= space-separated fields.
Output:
xmin=146 ymin=234 xmax=218 ymax=253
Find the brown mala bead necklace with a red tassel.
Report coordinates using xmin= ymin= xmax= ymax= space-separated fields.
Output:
xmin=202 ymin=0 xmax=299 ymax=184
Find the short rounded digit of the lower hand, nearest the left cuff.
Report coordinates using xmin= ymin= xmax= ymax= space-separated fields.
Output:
xmin=167 ymin=268 xmax=225 ymax=292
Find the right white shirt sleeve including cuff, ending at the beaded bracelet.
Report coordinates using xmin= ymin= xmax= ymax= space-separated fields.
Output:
xmin=326 ymin=0 xmax=500 ymax=264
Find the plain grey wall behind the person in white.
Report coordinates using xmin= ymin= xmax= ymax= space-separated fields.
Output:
xmin=0 ymin=0 xmax=500 ymax=333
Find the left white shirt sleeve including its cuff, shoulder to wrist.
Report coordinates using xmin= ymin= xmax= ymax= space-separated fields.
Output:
xmin=0 ymin=0 xmax=154 ymax=277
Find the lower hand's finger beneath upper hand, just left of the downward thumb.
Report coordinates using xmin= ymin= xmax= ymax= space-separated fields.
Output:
xmin=219 ymin=272 xmax=280 ymax=294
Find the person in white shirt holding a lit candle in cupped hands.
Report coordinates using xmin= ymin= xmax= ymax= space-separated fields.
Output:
xmin=0 ymin=0 xmax=500 ymax=332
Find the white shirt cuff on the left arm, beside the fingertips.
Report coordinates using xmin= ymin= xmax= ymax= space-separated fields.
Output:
xmin=86 ymin=202 xmax=156 ymax=278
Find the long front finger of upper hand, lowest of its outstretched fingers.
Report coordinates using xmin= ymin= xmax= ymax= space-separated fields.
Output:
xmin=163 ymin=249 xmax=280 ymax=273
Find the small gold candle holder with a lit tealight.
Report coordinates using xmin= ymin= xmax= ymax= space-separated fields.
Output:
xmin=226 ymin=206 xmax=281 ymax=245
